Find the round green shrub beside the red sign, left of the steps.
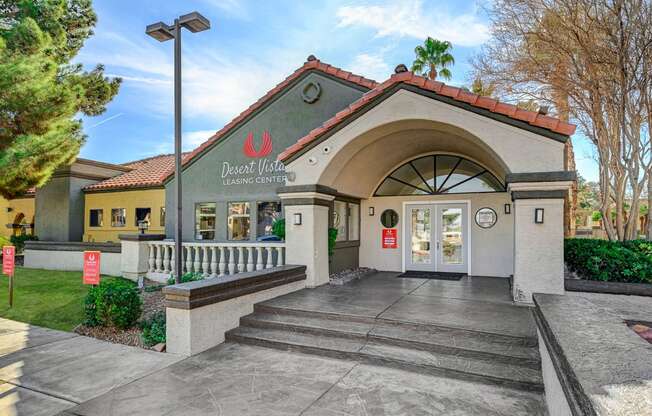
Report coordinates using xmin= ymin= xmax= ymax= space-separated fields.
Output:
xmin=84 ymin=279 xmax=143 ymax=329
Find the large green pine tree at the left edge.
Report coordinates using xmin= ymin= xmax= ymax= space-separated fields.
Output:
xmin=0 ymin=0 xmax=121 ymax=198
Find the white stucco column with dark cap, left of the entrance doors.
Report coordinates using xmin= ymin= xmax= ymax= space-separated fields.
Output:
xmin=281 ymin=202 xmax=333 ymax=287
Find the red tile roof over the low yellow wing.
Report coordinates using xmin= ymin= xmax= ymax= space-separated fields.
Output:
xmin=84 ymin=153 xmax=189 ymax=192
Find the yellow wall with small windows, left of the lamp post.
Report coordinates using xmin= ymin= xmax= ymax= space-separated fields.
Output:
xmin=84 ymin=188 xmax=165 ymax=243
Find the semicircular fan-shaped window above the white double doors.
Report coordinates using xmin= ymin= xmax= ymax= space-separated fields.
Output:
xmin=374 ymin=153 xmax=506 ymax=197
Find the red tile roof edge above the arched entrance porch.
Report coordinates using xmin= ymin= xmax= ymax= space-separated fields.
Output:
xmin=278 ymin=71 xmax=576 ymax=162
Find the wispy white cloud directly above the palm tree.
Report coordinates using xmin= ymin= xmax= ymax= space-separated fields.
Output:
xmin=337 ymin=0 xmax=489 ymax=46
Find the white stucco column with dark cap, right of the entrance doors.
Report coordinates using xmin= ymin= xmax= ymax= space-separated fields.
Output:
xmin=512 ymin=190 xmax=568 ymax=303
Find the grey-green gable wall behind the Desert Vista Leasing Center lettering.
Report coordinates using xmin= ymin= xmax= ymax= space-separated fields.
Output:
xmin=165 ymin=72 xmax=363 ymax=240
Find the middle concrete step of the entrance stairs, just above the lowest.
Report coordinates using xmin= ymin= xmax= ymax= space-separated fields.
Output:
xmin=240 ymin=310 xmax=541 ymax=369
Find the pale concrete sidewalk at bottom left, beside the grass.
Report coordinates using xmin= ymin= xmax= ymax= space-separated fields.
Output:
xmin=0 ymin=318 xmax=182 ymax=416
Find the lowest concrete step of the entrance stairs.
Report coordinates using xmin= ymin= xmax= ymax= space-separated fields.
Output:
xmin=226 ymin=326 xmax=543 ymax=391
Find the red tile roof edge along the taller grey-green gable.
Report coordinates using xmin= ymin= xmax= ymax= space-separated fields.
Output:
xmin=160 ymin=55 xmax=378 ymax=180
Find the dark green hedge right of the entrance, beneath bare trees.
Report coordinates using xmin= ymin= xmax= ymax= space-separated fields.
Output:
xmin=564 ymin=238 xmax=652 ymax=283
